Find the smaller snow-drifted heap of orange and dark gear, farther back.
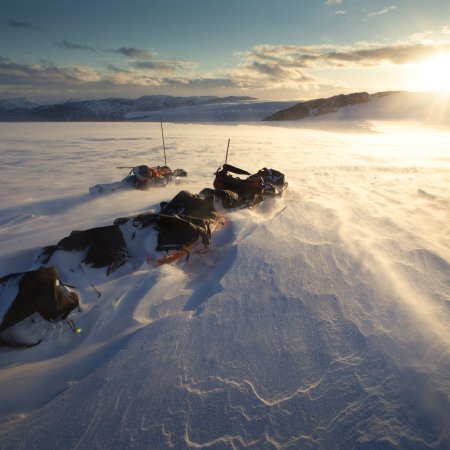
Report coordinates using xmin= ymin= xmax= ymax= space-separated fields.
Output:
xmin=89 ymin=164 xmax=187 ymax=194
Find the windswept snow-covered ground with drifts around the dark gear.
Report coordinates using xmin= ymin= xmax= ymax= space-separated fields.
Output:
xmin=0 ymin=121 xmax=450 ymax=449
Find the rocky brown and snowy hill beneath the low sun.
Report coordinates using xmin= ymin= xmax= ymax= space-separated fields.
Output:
xmin=263 ymin=91 xmax=450 ymax=125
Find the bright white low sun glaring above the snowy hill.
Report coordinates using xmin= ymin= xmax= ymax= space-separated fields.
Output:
xmin=417 ymin=53 xmax=450 ymax=92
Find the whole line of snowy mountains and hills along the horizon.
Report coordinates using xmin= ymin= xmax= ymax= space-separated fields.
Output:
xmin=0 ymin=91 xmax=450 ymax=125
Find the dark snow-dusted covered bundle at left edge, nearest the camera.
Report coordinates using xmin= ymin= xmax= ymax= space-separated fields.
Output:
xmin=0 ymin=267 xmax=79 ymax=347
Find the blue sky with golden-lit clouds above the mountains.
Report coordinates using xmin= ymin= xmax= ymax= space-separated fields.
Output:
xmin=0 ymin=0 xmax=450 ymax=101
